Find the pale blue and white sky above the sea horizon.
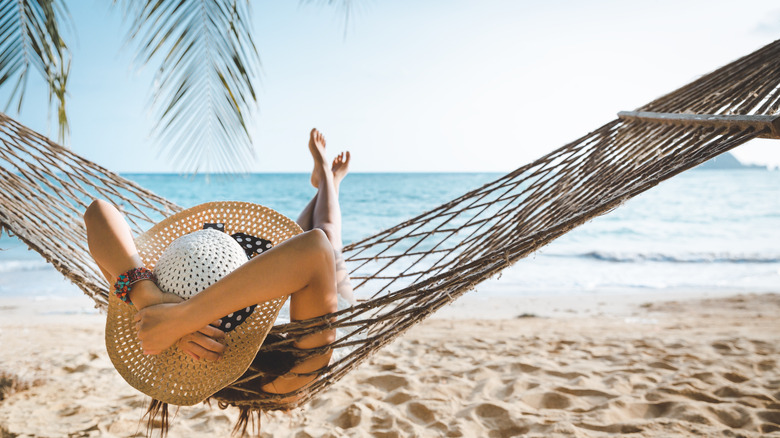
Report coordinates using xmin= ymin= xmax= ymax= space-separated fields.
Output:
xmin=0 ymin=0 xmax=780 ymax=172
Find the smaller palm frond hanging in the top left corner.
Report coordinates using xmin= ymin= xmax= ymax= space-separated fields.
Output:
xmin=0 ymin=0 xmax=70 ymax=143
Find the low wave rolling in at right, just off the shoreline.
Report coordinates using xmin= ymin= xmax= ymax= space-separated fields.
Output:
xmin=573 ymin=251 xmax=780 ymax=263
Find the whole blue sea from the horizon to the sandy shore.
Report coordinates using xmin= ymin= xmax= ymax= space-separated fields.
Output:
xmin=0 ymin=169 xmax=780 ymax=308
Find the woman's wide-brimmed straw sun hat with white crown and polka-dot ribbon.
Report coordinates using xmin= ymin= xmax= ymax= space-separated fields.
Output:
xmin=106 ymin=202 xmax=301 ymax=406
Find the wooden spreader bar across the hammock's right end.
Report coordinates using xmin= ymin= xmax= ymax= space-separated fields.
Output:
xmin=618 ymin=111 xmax=780 ymax=139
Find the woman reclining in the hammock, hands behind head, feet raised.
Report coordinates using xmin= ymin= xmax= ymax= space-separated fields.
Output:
xmin=84 ymin=129 xmax=354 ymax=393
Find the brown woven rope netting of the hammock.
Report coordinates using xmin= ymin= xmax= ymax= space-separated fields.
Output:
xmin=0 ymin=40 xmax=780 ymax=410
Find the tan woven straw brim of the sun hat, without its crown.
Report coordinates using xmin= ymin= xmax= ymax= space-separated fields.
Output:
xmin=106 ymin=202 xmax=302 ymax=406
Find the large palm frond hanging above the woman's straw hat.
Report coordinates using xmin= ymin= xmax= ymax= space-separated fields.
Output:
xmin=115 ymin=0 xmax=260 ymax=172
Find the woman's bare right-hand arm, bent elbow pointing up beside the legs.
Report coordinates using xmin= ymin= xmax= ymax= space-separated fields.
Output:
xmin=135 ymin=230 xmax=337 ymax=354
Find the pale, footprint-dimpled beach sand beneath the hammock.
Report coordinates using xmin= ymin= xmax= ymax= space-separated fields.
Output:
xmin=0 ymin=294 xmax=780 ymax=437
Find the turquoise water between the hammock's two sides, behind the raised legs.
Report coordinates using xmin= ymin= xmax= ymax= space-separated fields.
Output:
xmin=124 ymin=173 xmax=501 ymax=243
